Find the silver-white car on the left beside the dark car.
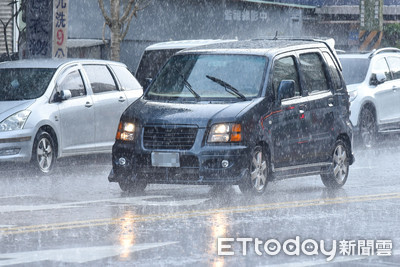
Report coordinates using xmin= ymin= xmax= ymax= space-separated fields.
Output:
xmin=0 ymin=59 xmax=143 ymax=173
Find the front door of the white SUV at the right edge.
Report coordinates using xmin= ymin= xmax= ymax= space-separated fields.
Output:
xmin=370 ymin=57 xmax=400 ymax=124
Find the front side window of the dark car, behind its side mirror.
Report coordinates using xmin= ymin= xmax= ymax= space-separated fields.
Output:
xmin=272 ymin=56 xmax=301 ymax=98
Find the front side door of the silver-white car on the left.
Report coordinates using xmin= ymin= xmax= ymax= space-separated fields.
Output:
xmin=57 ymin=67 xmax=95 ymax=155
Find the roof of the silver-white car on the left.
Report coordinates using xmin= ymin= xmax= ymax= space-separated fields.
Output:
xmin=0 ymin=58 xmax=126 ymax=69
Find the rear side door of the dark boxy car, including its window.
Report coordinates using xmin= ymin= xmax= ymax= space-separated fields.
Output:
xmin=299 ymin=50 xmax=337 ymax=163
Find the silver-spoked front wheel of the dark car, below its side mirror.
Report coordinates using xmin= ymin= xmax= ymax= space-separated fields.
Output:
xmin=239 ymin=146 xmax=270 ymax=195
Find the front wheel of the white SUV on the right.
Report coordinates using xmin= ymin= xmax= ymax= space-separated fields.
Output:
xmin=360 ymin=108 xmax=377 ymax=148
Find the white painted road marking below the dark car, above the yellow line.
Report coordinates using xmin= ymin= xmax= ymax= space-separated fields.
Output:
xmin=0 ymin=196 xmax=209 ymax=213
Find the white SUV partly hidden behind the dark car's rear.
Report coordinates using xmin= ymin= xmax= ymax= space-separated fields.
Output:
xmin=339 ymin=48 xmax=400 ymax=147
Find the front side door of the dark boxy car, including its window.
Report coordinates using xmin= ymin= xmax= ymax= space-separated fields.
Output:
xmin=263 ymin=55 xmax=309 ymax=168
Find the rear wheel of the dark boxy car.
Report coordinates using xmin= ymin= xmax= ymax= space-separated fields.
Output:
xmin=321 ymin=140 xmax=350 ymax=188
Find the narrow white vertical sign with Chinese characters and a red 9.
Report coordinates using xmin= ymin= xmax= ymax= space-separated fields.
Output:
xmin=52 ymin=0 xmax=69 ymax=58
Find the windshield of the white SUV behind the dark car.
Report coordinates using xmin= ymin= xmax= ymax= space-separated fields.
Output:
xmin=340 ymin=58 xmax=369 ymax=84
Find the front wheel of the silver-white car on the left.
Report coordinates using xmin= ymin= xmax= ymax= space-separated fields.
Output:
xmin=31 ymin=130 xmax=57 ymax=174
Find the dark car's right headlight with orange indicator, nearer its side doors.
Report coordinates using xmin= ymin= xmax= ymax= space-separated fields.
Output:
xmin=208 ymin=123 xmax=242 ymax=143
